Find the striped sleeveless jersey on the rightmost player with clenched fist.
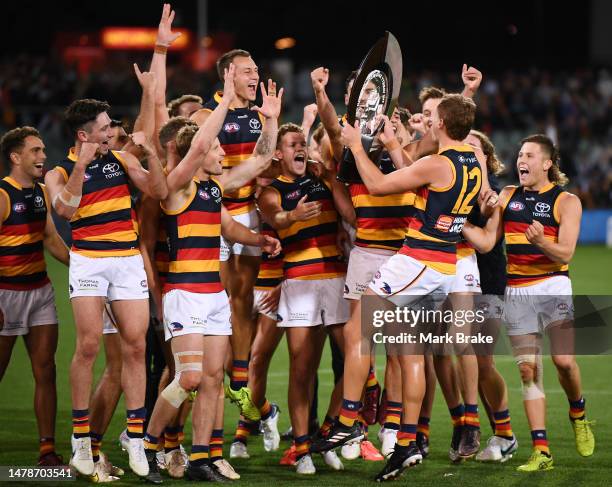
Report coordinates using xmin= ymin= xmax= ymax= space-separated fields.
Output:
xmin=503 ymin=183 xmax=569 ymax=287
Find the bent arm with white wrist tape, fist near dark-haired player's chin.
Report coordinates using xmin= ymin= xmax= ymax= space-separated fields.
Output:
xmin=45 ymin=142 xmax=99 ymax=220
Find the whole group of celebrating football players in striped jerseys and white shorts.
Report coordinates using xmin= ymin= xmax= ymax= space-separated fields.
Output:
xmin=0 ymin=4 xmax=595 ymax=483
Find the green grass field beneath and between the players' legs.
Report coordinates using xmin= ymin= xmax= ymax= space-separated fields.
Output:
xmin=0 ymin=247 xmax=612 ymax=487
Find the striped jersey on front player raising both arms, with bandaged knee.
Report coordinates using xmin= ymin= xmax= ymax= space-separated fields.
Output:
xmin=162 ymin=178 xmax=223 ymax=294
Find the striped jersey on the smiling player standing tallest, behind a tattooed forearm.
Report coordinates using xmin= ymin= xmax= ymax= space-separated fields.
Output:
xmin=204 ymin=91 xmax=263 ymax=215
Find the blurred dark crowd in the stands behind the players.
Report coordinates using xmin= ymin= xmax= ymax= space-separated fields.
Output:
xmin=0 ymin=53 xmax=612 ymax=208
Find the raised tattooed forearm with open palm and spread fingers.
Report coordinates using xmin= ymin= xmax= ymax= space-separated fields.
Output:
xmin=220 ymin=79 xmax=283 ymax=192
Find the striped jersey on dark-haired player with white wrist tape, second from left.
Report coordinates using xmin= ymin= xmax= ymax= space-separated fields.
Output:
xmin=55 ymin=149 xmax=140 ymax=257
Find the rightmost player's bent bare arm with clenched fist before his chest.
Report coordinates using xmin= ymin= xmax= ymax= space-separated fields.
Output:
xmin=525 ymin=193 xmax=582 ymax=264
